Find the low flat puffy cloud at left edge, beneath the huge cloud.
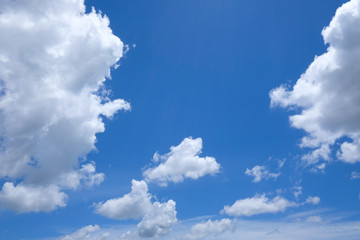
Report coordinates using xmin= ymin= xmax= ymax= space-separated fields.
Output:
xmin=0 ymin=182 xmax=67 ymax=213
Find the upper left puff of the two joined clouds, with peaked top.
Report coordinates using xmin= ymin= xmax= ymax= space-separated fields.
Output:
xmin=96 ymin=180 xmax=152 ymax=220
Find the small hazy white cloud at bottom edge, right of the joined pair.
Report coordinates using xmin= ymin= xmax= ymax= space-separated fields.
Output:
xmin=186 ymin=218 xmax=234 ymax=239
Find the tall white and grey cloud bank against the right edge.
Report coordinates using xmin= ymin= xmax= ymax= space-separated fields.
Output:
xmin=270 ymin=0 xmax=360 ymax=164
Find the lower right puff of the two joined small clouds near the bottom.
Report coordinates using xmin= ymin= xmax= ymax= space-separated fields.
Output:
xmin=137 ymin=200 xmax=177 ymax=238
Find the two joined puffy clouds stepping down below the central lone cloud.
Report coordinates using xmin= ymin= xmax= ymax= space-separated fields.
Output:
xmin=95 ymin=180 xmax=177 ymax=239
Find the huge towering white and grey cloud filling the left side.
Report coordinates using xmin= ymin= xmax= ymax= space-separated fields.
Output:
xmin=0 ymin=0 xmax=130 ymax=211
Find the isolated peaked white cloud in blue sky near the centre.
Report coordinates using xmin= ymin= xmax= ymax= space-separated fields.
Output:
xmin=143 ymin=138 xmax=220 ymax=186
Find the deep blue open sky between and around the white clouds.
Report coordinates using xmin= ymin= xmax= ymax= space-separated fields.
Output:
xmin=0 ymin=0 xmax=360 ymax=239
